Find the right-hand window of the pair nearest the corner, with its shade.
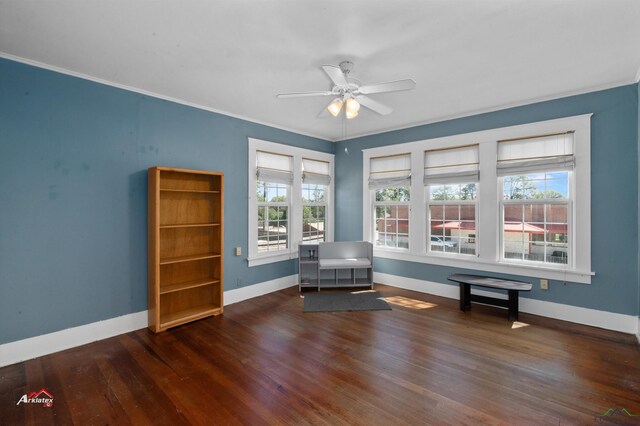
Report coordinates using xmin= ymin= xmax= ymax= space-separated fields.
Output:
xmin=302 ymin=158 xmax=331 ymax=242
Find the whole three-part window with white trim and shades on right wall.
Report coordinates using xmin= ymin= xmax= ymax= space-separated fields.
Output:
xmin=362 ymin=114 xmax=593 ymax=283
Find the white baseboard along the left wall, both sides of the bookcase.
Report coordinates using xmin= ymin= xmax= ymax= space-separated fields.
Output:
xmin=0 ymin=274 xmax=298 ymax=367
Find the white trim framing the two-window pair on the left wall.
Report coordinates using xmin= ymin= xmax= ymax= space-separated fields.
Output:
xmin=247 ymin=138 xmax=335 ymax=267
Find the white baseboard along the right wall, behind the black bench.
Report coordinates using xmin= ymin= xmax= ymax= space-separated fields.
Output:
xmin=373 ymin=272 xmax=640 ymax=341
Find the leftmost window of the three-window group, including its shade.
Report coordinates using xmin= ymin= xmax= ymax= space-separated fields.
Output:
xmin=369 ymin=154 xmax=411 ymax=249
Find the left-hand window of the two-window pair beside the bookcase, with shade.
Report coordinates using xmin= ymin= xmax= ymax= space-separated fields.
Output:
xmin=256 ymin=151 xmax=293 ymax=253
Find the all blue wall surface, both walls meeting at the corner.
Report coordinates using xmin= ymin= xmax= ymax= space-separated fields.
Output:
xmin=0 ymin=55 xmax=640 ymax=344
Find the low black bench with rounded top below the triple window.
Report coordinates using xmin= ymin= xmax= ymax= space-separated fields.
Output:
xmin=449 ymin=274 xmax=532 ymax=321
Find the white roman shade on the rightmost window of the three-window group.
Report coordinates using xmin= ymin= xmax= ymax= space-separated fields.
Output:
xmin=497 ymin=132 xmax=575 ymax=176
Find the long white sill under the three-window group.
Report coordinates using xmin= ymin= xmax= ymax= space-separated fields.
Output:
xmin=373 ymin=248 xmax=595 ymax=284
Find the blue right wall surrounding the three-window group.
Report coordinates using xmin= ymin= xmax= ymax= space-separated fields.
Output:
xmin=335 ymin=84 xmax=640 ymax=315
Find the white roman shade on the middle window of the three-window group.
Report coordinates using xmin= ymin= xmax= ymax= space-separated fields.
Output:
xmin=423 ymin=145 xmax=480 ymax=185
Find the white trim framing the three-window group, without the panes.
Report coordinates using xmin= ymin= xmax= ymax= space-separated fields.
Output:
xmin=362 ymin=114 xmax=595 ymax=284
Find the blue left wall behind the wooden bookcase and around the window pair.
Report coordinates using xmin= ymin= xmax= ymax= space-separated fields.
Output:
xmin=0 ymin=59 xmax=334 ymax=344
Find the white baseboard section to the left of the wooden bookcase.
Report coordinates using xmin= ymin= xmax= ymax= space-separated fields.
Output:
xmin=0 ymin=311 xmax=148 ymax=367
